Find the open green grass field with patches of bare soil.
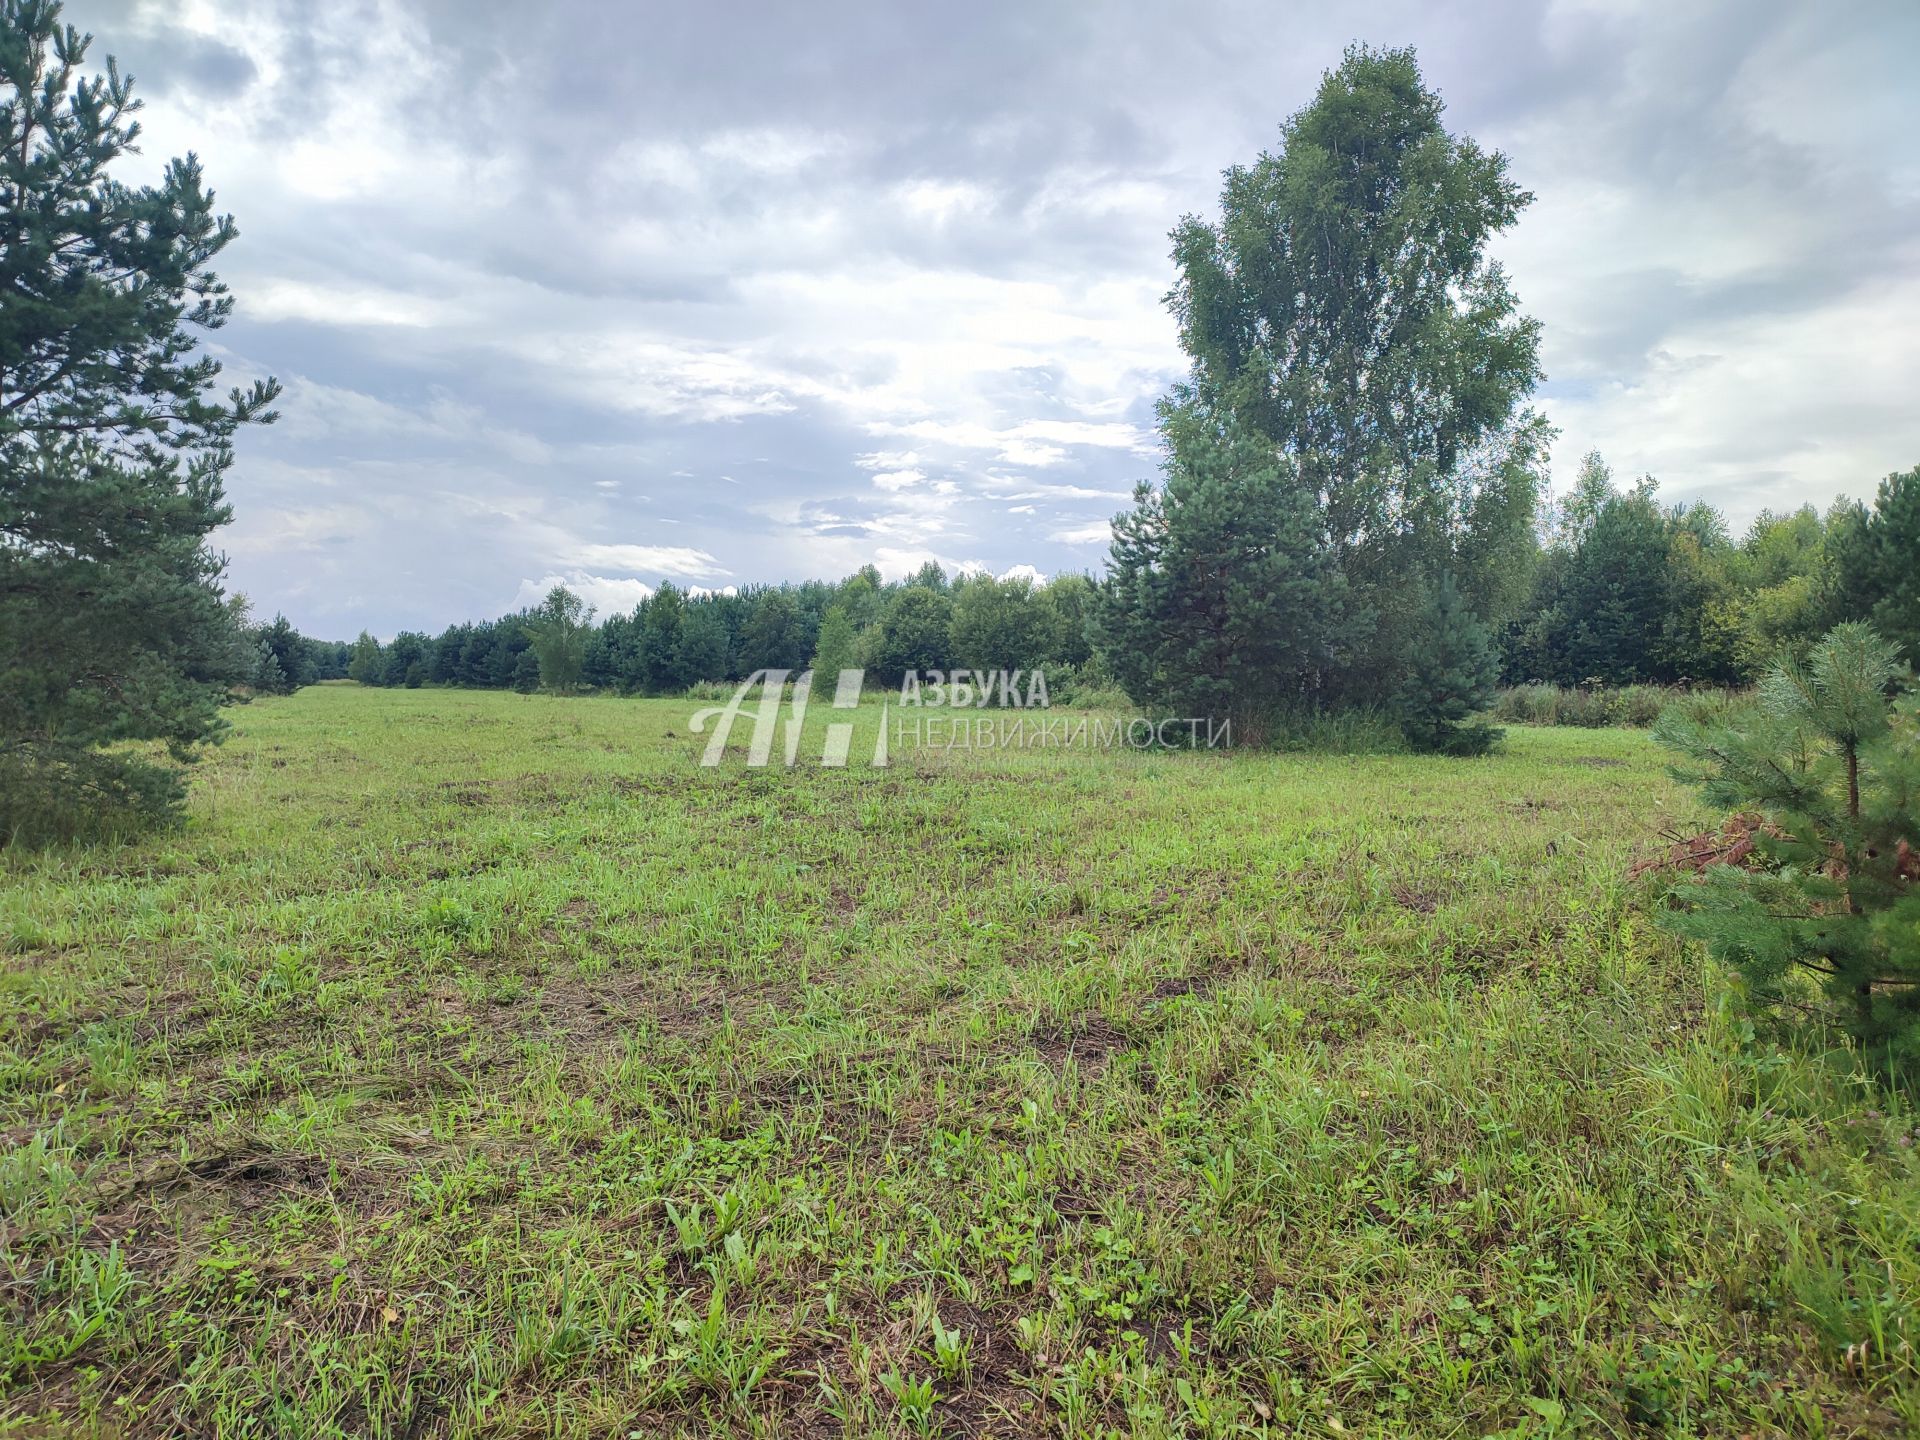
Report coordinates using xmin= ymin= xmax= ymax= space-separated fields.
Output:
xmin=0 ymin=685 xmax=1920 ymax=1436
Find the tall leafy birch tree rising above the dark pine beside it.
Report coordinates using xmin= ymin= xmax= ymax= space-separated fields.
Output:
xmin=1171 ymin=46 xmax=1548 ymax=699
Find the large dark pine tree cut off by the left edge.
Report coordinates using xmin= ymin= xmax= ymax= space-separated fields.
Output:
xmin=0 ymin=0 xmax=278 ymax=841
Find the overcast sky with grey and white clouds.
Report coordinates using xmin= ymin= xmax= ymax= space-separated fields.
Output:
xmin=67 ymin=0 xmax=1920 ymax=637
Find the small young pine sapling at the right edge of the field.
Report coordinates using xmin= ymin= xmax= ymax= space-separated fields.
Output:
xmin=1655 ymin=622 xmax=1920 ymax=1068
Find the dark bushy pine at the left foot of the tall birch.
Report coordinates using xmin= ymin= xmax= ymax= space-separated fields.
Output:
xmin=1100 ymin=414 xmax=1367 ymax=735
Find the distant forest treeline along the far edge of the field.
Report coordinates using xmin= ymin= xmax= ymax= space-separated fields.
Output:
xmin=307 ymin=455 xmax=1920 ymax=695
